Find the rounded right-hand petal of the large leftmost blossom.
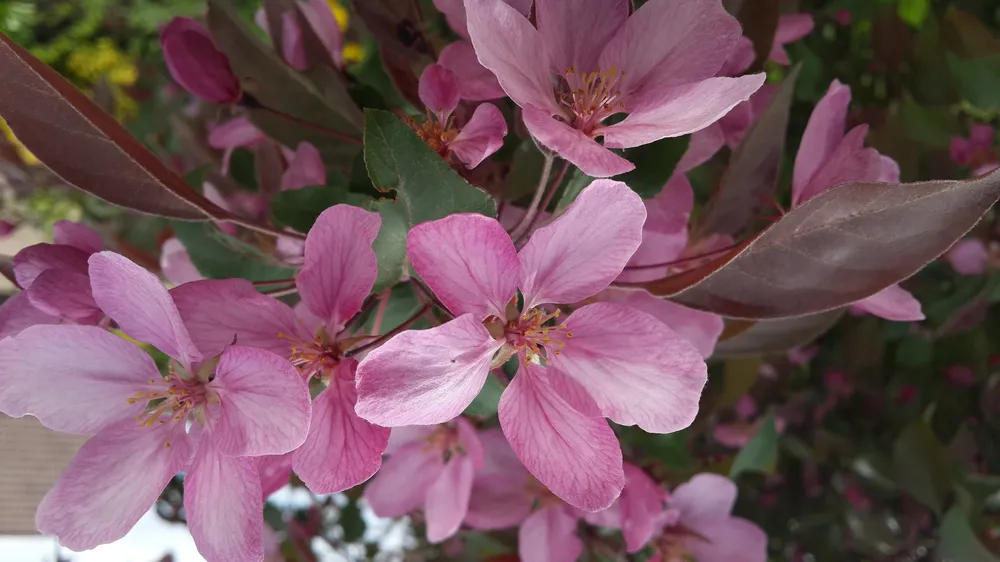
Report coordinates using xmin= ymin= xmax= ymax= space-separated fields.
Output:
xmin=205 ymin=345 xmax=311 ymax=456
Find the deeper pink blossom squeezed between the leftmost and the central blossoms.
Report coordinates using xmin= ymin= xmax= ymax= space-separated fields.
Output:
xmin=171 ymin=205 xmax=389 ymax=494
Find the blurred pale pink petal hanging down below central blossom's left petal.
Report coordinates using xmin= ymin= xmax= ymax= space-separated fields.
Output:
xmin=424 ymin=455 xmax=475 ymax=543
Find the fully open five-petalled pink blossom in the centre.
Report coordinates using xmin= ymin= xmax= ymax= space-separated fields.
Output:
xmin=356 ymin=180 xmax=706 ymax=511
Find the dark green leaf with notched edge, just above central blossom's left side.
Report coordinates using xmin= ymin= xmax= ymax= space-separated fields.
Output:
xmin=365 ymin=110 xmax=496 ymax=292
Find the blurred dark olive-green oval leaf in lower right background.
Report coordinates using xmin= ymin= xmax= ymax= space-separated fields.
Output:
xmin=893 ymin=417 xmax=952 ymax=514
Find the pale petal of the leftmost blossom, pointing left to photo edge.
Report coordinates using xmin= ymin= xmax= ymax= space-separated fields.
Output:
xmin=0 ymin=325 xmax=154 ymax=434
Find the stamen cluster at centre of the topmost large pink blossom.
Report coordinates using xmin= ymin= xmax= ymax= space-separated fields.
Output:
xmin=558 ymin=67 xmax=625 ymax=136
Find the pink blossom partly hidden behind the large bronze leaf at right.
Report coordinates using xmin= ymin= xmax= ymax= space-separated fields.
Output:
xmin=792 ymin=80 xmax=924 ymax=322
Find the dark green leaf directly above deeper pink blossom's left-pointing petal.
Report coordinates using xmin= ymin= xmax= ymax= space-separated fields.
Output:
xmin=171 ymin=221 xmax=295 ymax=281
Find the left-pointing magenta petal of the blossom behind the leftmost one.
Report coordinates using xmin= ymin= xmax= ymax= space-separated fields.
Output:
xmin=170 ymin=279 xmax=304 ymax=357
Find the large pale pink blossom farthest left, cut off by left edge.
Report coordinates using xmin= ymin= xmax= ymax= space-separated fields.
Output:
xmin=0 ymin=252 xmax=310 ymax=562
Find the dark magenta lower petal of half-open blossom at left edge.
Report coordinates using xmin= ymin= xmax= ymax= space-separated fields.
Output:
xmin=25 ymin=269 xmax=104 ymax=324
